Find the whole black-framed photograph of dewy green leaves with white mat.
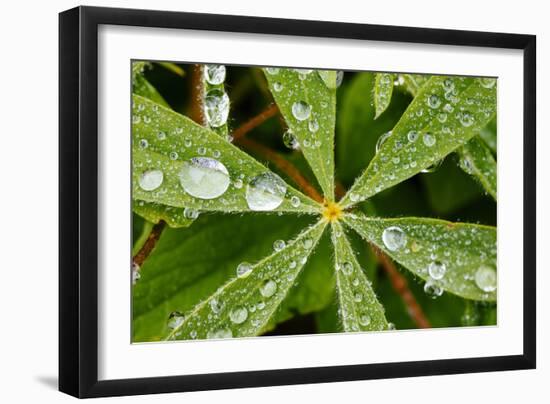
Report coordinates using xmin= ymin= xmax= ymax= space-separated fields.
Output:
xmin=59 ymin=7 xmax=536 ymax=397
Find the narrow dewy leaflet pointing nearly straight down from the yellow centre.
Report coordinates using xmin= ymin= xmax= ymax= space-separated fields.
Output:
xmin=332 ymin=222 xmax=388 ymax=332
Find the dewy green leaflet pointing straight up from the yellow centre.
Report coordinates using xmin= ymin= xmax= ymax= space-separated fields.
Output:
xmin=264 ymin=68 xmax=336 ymax=200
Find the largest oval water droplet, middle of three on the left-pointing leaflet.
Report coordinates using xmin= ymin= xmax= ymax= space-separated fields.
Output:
xmin=179 ymin=157 xmax=229 ymax=199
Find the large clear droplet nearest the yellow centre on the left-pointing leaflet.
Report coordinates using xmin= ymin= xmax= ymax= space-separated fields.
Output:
xmin=246 ymin=172 xmax=286 ymax=211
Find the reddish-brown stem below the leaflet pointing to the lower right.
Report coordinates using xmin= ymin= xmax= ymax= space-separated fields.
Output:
xmin=370 ymin=244 xmax=431 ymax=328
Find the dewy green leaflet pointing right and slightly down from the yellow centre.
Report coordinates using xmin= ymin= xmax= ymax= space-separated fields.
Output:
xmin=344 ymin=213 xmax=497 ymax=301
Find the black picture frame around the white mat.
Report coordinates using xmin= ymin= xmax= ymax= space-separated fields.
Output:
xmin=59 ymin=7 xmax=536 ymax=398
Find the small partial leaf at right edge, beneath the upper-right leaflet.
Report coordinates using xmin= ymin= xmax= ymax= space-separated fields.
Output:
xmin=458 ymin=137 xmax=497 ymax=201
